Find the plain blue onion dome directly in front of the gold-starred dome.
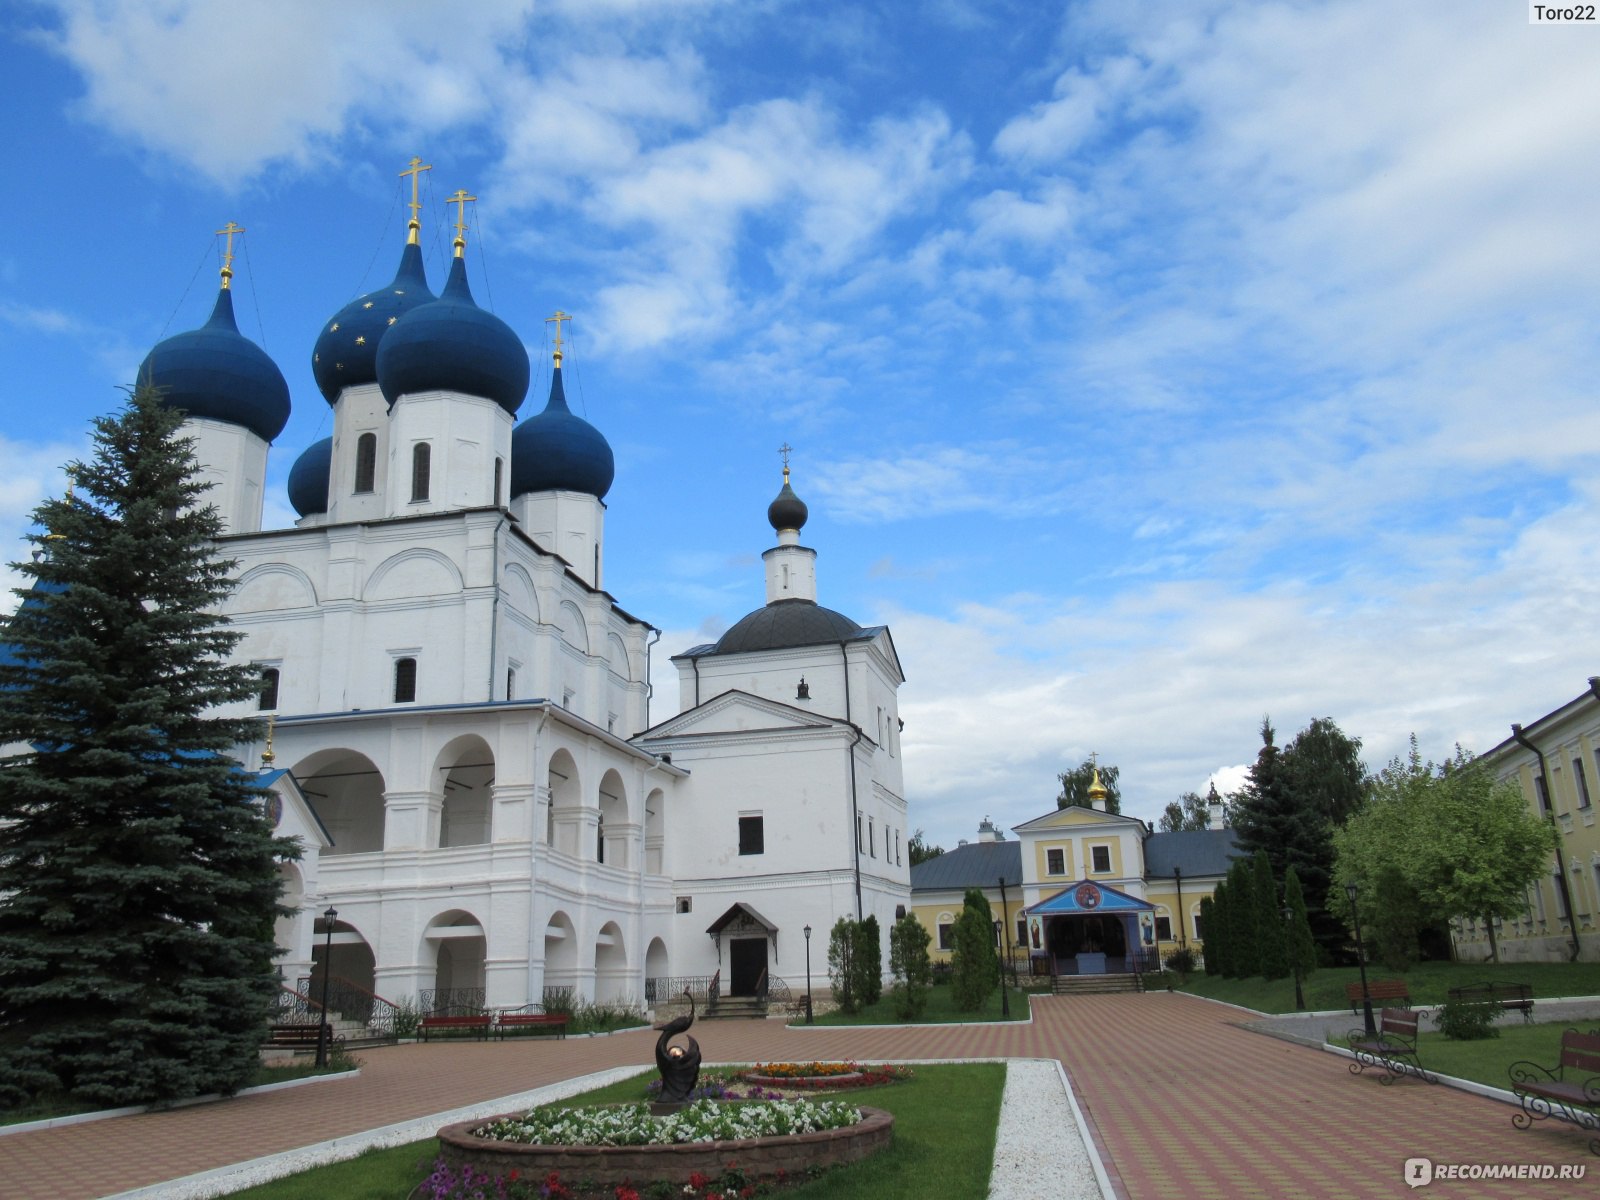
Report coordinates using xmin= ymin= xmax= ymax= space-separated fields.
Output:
xmin=378 ymin=258 xmax=528 ymax=416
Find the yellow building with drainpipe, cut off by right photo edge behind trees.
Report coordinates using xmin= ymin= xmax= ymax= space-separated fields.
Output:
xmin=1465 ymin=675 xmax=1600 ymax=962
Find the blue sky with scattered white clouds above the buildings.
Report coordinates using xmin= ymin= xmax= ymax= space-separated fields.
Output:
xmin=0 ymin=0 xmax=1600 ymax=846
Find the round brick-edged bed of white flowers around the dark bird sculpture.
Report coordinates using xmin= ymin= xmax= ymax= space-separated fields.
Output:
xmin=438 ymin=1101 xmax=894 ymax=1186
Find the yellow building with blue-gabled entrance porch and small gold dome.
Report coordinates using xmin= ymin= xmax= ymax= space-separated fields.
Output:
xmin=910 ymin=790 xmax=1238 ymax=976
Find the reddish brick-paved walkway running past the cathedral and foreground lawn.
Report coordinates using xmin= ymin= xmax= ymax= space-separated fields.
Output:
xmin=0 ymin=992 xmax=1600 ymax=1200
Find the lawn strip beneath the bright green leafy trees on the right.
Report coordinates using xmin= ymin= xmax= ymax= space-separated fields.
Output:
xmin=1178 ymin=963 xmax=1600 ymax=1018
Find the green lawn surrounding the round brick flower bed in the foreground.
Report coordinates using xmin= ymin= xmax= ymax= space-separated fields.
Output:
xmin=235 ymin=1062 xmax=1005 ymax=1200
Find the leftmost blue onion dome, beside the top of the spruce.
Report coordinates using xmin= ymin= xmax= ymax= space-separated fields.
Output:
xmin=139 ymin=286 xmax=290 ymax=442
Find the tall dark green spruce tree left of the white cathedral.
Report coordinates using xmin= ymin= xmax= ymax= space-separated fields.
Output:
xmin=0 ymin=390 xmax=298 ymax=1104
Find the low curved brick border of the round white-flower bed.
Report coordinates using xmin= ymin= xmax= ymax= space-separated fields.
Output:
xmin=438 ymin=1107 xmax=894 ymax=1186
